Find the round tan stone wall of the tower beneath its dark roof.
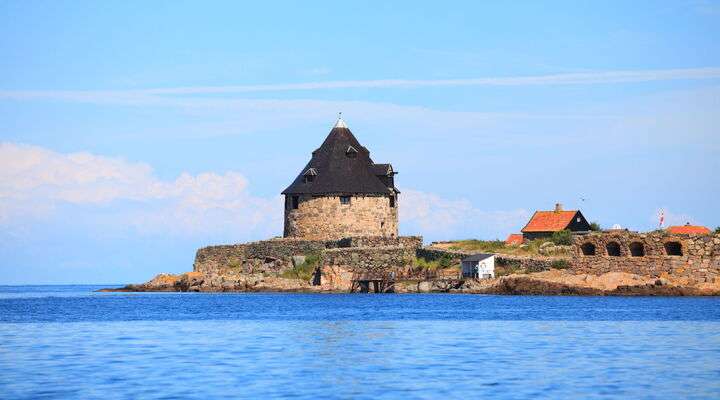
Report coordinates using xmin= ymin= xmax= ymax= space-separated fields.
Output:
xmin=284 ymin=196 xmax=398 ymax=240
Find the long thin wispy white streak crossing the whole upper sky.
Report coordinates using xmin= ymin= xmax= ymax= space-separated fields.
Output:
xmin=0 ymin=68 xmax=720 ymax=101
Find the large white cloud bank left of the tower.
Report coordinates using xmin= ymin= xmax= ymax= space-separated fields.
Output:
xmin=0 ymin=143 xmax=282 ymax=236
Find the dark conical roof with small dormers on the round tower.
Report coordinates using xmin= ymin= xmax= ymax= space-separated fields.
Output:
xmin=282 ymin=120 xmax=397 ymax=195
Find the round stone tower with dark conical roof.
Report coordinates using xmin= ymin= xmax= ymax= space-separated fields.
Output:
xmin=282 ymin=118 xmax=400 ymax=240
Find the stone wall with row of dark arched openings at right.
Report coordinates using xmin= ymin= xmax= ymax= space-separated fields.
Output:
xmin=571 ymin=231 xmax=720 ymax=284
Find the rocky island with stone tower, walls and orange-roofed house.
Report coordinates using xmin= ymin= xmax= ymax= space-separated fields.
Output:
xmin=108 ymin=118 xmax=720 ymax=295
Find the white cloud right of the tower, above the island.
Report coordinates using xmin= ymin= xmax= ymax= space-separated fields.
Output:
xmin=399 ymin=189 xmax=530 ymax=240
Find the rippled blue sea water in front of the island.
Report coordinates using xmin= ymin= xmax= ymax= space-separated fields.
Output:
xmin=0 ymin=286 xmax=720 ymax=399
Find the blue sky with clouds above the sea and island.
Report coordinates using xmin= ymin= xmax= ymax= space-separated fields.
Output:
xmin=0 ymin=1 xmax=720 ymax=284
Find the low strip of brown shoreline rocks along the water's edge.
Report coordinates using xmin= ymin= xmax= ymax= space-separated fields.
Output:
xmin=100 ymin=270 xmax=720 ymax=296
